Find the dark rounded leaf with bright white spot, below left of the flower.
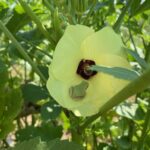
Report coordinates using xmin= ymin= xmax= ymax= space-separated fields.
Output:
xmin=41 ymin=101 xmax=61 ymax=121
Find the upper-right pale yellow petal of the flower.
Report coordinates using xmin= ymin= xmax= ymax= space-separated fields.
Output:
xmin=81 ymin=27 xmax=126 ymax=57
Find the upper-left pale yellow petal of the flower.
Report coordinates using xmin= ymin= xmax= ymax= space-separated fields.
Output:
xmin=50 ymin=25 xmax=94 ymax=81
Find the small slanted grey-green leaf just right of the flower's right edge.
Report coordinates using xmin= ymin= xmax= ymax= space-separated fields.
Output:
xmin=126 ymin=49 xmax=148 ymax=69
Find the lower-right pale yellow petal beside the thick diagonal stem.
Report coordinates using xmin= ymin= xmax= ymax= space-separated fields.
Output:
xmin=72 ymin=73 xmax=129 ymax=117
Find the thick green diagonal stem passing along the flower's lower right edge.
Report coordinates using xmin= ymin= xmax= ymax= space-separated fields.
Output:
xmin=80 ymin=69 xmax=150 ymax=131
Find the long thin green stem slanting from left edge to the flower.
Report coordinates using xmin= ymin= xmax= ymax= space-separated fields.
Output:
xmin=0 ymin=20 xmax=46 ymax=82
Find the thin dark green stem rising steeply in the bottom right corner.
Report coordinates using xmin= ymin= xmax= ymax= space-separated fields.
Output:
xmin=137 ymin=103 xmax=150 ymax=150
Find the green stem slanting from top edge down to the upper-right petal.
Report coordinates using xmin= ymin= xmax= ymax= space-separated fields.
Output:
xmin=113 ymin=0 xmax=134 ymax=32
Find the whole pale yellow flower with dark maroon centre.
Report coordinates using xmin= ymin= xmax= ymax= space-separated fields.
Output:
xmin=47 ymin=25 xmax=130 ymax=117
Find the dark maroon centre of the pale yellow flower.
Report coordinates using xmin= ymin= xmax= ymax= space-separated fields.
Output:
xmin=76 ymin=59 xmax=97 ymax=80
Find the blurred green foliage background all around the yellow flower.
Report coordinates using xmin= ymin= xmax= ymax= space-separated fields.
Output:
xmin=0 ymin=0 xmax=150 ymax=150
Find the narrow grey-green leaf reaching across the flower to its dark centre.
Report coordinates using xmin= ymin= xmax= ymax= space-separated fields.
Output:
xmin=90 ymin=65 xmax=138 ymax=80
